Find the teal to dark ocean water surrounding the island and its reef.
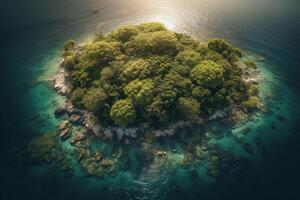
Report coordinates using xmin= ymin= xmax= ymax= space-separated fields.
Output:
xmin=0 ymin=0 xmax=300 ymax=199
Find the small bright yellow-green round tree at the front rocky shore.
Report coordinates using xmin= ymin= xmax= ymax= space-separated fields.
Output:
xmin=110 ymin=99 xmax=136 ymax=126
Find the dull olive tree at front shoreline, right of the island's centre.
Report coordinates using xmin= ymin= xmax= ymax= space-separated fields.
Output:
xmin=178 ymin=97 xmax=200 ymax=119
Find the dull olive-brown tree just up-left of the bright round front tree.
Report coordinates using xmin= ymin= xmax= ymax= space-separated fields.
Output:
xmin=82 ymin=88 xmax=107 ymax=113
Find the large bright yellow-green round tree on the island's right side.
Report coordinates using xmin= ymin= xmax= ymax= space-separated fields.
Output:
xmin=191 ymin=61 xmax=224 ymax=89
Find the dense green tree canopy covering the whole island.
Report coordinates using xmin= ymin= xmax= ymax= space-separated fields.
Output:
xmin=62 ymin=22 xmax=258 ymax=126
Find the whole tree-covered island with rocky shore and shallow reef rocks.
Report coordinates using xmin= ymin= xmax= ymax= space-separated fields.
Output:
xmin=30 ymin=22 xmax=261 ymax=177
